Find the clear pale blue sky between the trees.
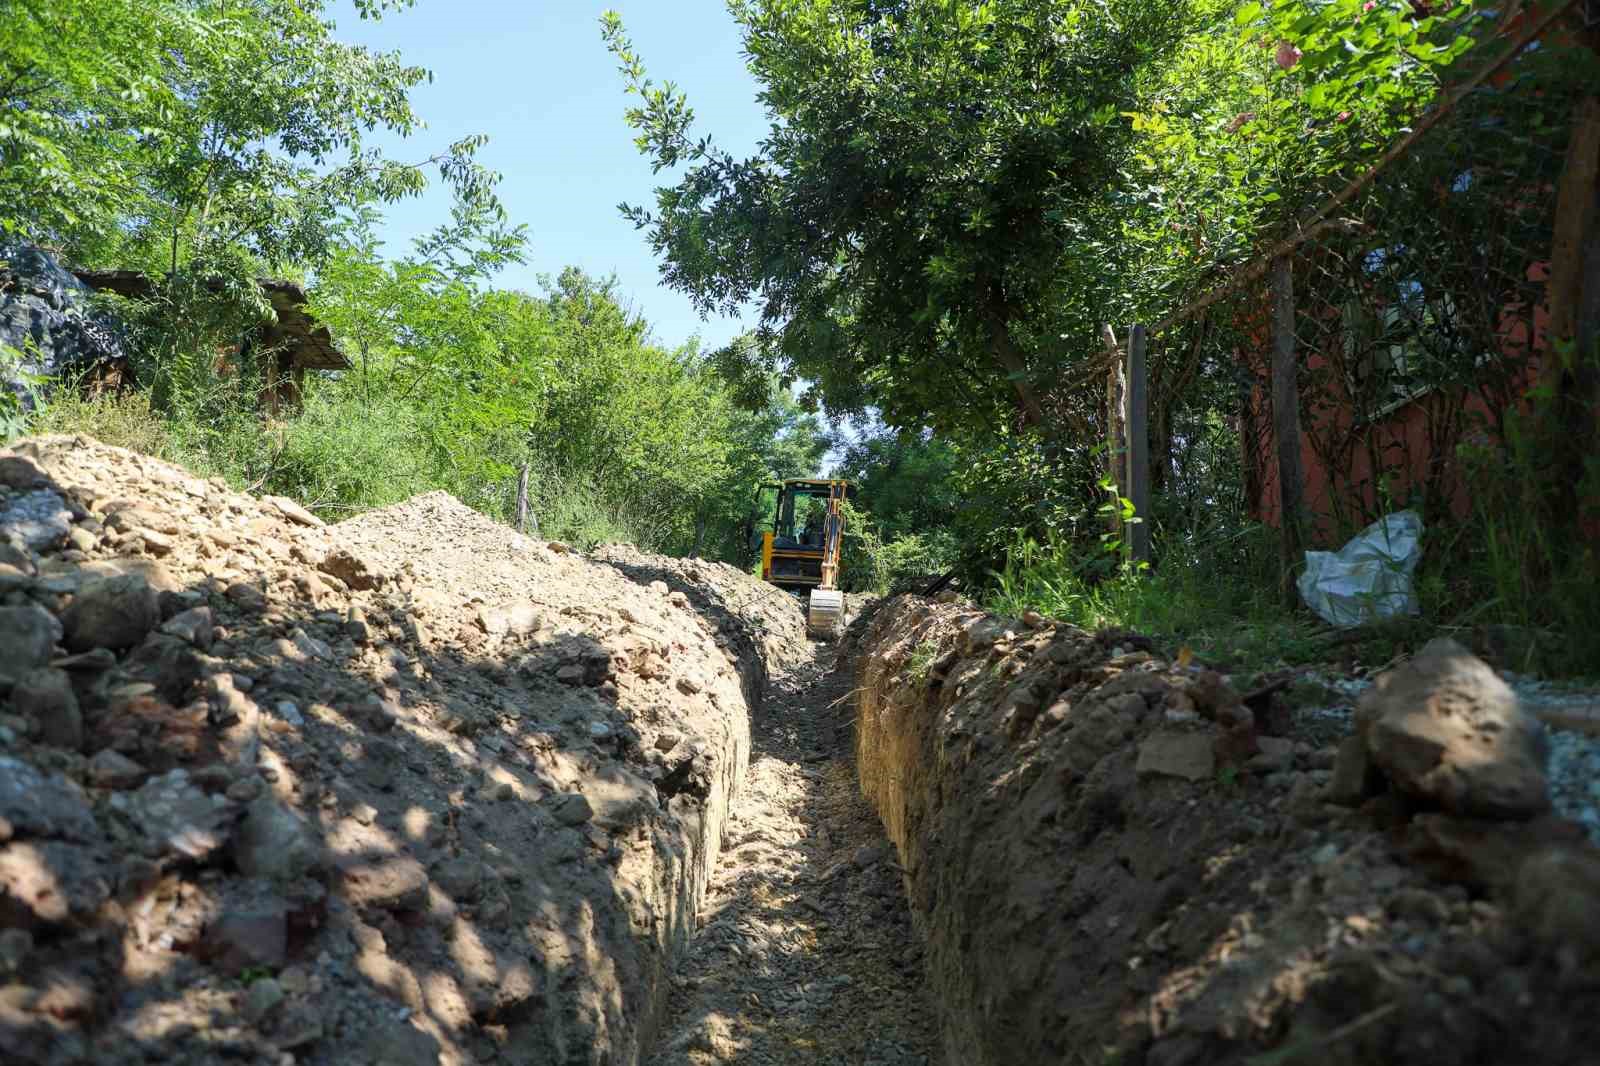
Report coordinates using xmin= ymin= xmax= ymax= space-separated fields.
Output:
xmin=336 ymin=0 xmax=766 ymax=346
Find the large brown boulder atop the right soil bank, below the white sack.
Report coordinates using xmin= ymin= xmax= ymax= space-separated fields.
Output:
xmin=1357 ymin=640 xmax=1550 ymax=818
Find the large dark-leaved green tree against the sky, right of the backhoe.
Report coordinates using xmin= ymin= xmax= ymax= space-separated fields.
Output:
xmin=605 ymin=0 xmax=1192 ymax=427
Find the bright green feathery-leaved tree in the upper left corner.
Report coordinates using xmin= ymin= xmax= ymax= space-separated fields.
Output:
xmin=0 ymin=0 xmax=501 ymax=408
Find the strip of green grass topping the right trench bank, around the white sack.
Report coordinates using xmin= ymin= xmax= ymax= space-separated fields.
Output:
xmin=986 ymin=480 xmax=1600 ymax=677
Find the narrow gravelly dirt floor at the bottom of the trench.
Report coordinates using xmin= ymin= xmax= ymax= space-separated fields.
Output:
xmin=646 ymin=645 xmax=938 ymax=1066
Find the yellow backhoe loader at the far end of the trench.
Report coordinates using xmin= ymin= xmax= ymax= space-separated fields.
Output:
xmin=757 ymin=479 xmax=853 ymax=637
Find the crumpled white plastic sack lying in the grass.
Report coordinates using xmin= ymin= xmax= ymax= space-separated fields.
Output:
xmin=1299 ymin=511 xmax=1422 ymax=627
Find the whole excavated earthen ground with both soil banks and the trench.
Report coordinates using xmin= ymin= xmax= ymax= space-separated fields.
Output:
xmin=0 ymin=437 xmax=1600 ymax=1066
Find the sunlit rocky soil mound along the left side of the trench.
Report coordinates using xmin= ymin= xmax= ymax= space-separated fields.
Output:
xmin=0 ymin=437 xmax=802 ymax=1066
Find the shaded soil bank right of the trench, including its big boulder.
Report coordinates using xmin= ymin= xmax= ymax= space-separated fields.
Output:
xmin=858 ymin=597 xmax=1600 ymax=1066
